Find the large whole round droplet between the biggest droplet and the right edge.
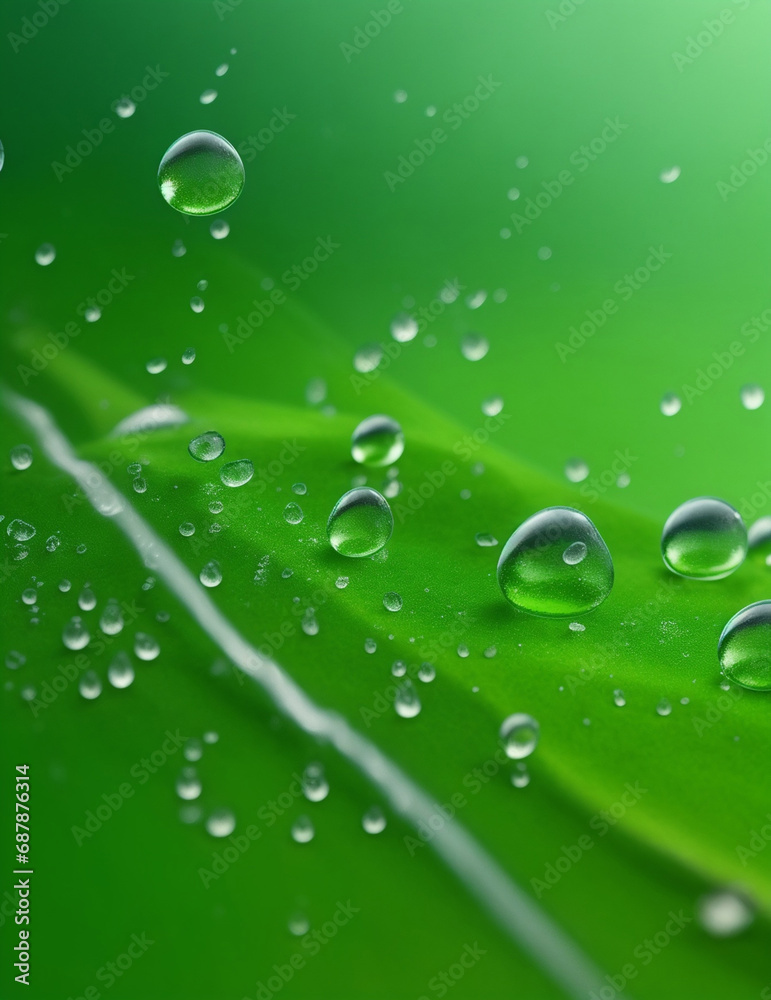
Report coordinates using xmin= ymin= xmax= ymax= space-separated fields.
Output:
xmin=661 ymin=497 xmax=747 ymax=580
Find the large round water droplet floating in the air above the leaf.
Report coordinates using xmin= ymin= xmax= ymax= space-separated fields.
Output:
xmin=158 ymin=131 xmax=244 ymax=215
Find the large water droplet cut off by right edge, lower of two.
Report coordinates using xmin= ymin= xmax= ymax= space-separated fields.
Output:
xmin=718 ymin=601 xmax=771 ymax=691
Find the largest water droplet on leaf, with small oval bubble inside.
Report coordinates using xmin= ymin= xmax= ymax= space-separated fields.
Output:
xmin=498 ymin=507 xmax=613 ymax=618
